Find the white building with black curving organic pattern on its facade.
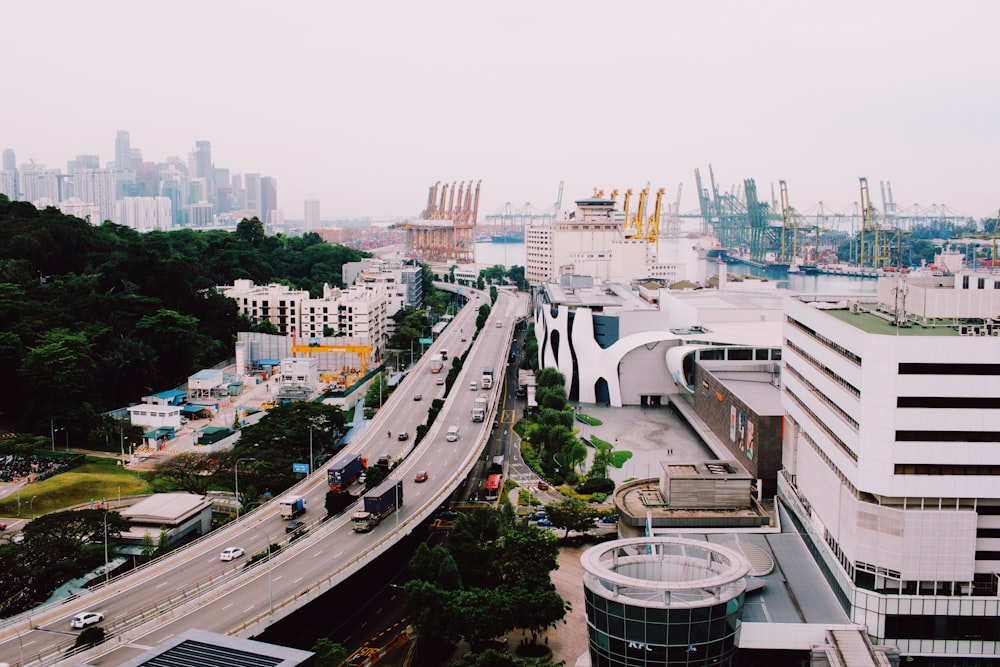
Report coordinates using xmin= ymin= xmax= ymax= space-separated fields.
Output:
xmin=534 ymin=275 xmax=783 ymax=406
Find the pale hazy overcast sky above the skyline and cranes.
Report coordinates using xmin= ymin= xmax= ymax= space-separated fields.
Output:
xmin=0 ymin=0 xmax=1000 ymax=221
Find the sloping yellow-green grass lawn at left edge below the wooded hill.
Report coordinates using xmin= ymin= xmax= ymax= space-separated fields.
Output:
xmin=0 ymin=456 xmax=152 ymax=519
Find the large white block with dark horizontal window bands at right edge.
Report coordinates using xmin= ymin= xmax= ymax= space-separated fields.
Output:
xmin=779 ymin=271 xmax=1000 ymax=665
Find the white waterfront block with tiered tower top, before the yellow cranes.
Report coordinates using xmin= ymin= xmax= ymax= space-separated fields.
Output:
xmin=525 ymin=197 xmax=685 ymax=286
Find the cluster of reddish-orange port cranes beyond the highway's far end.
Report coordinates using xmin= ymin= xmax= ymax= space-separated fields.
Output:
xmin=403 ymin=181 xmax=482 ymax=264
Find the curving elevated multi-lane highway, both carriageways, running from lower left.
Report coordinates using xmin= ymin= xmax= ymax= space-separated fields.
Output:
xmin=0 ymin=292 xmax=527 ymax=666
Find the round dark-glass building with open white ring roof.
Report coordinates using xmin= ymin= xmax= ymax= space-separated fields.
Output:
xmin=580 ymin=537 xmax=750 ymax=667
